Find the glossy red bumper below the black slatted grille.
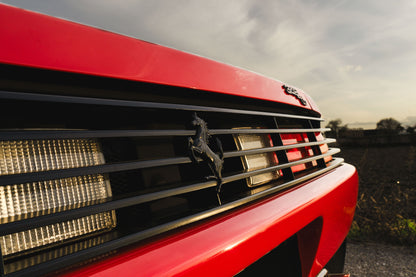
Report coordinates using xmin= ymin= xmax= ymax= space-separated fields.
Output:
xmin=61 ymin=164 xmax=358 ymax=277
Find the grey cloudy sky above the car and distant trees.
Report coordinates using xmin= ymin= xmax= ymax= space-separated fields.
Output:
xmin=4 ymin=0 xmax=416 ymax=128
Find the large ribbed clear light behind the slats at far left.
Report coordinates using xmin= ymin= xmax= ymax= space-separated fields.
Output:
xmin=0 ymin=139 xmax=116 ymax=256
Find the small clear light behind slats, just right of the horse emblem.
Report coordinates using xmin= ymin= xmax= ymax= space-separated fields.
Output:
xmin=234 ymin=134 xmax=280 ymax=187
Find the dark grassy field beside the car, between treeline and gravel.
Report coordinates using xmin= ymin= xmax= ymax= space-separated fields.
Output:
xmin=341 ymin=145 xmax=416 ymax=245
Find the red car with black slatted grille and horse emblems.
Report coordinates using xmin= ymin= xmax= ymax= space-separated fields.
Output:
xmin=0 ymin=5 xmax=358 ymax=276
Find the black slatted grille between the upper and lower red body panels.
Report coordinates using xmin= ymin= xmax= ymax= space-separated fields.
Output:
xmin=0 ymin=91 xmax=343 ymax=276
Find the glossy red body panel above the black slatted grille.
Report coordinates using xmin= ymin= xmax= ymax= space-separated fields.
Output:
xmin=0 ymin=4 xmax=318 ymax=111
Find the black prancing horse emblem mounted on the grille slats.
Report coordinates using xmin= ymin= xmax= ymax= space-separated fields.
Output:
xmin=188 ymin=113 xmax=224 ymax=201
